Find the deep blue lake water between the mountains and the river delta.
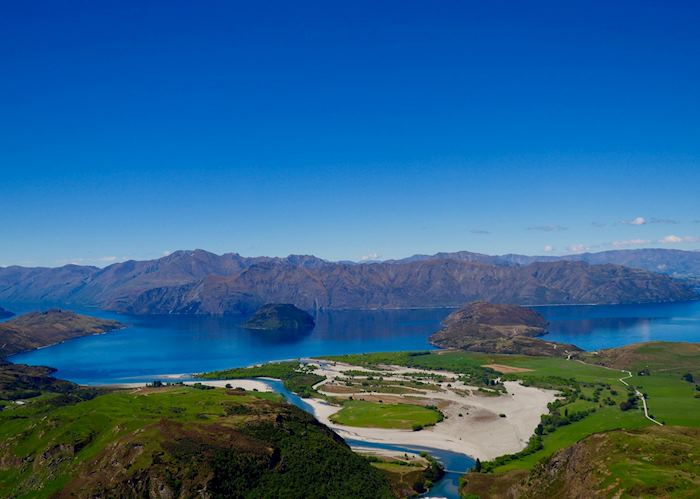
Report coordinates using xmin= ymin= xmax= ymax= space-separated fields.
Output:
xmin=6 ymin=302 xmax=700 ymax=384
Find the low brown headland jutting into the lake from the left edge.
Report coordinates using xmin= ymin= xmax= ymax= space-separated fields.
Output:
xmin=0 ymin=309 xmax=123 ymax=358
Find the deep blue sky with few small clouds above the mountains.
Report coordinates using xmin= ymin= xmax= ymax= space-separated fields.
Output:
xmin=0 ymin=0 xmax=700 ymax=266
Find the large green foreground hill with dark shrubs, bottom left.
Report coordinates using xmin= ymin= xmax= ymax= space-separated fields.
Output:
xmin=0 ymin=386 xmax=392 ymax=498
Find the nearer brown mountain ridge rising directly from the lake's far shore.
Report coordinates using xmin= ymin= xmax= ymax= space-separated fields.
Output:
xmin=123 ymin=260 xmax=697 ymax=314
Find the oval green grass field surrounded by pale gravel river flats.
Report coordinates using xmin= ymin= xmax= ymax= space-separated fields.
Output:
xmin=331 ymin=400 xmax=442 ymax=430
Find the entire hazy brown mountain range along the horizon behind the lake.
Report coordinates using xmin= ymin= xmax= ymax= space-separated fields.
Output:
xmin=0 ymin=249 xmax=700 ymax=314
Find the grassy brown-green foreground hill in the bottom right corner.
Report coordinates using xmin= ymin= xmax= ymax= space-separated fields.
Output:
xmin=462 ymin=426 xmax=700 ymax=499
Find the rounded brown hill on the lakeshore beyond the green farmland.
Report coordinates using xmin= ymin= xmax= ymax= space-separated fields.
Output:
xmin=430 ymin=301 xmax=580 ymax=356
